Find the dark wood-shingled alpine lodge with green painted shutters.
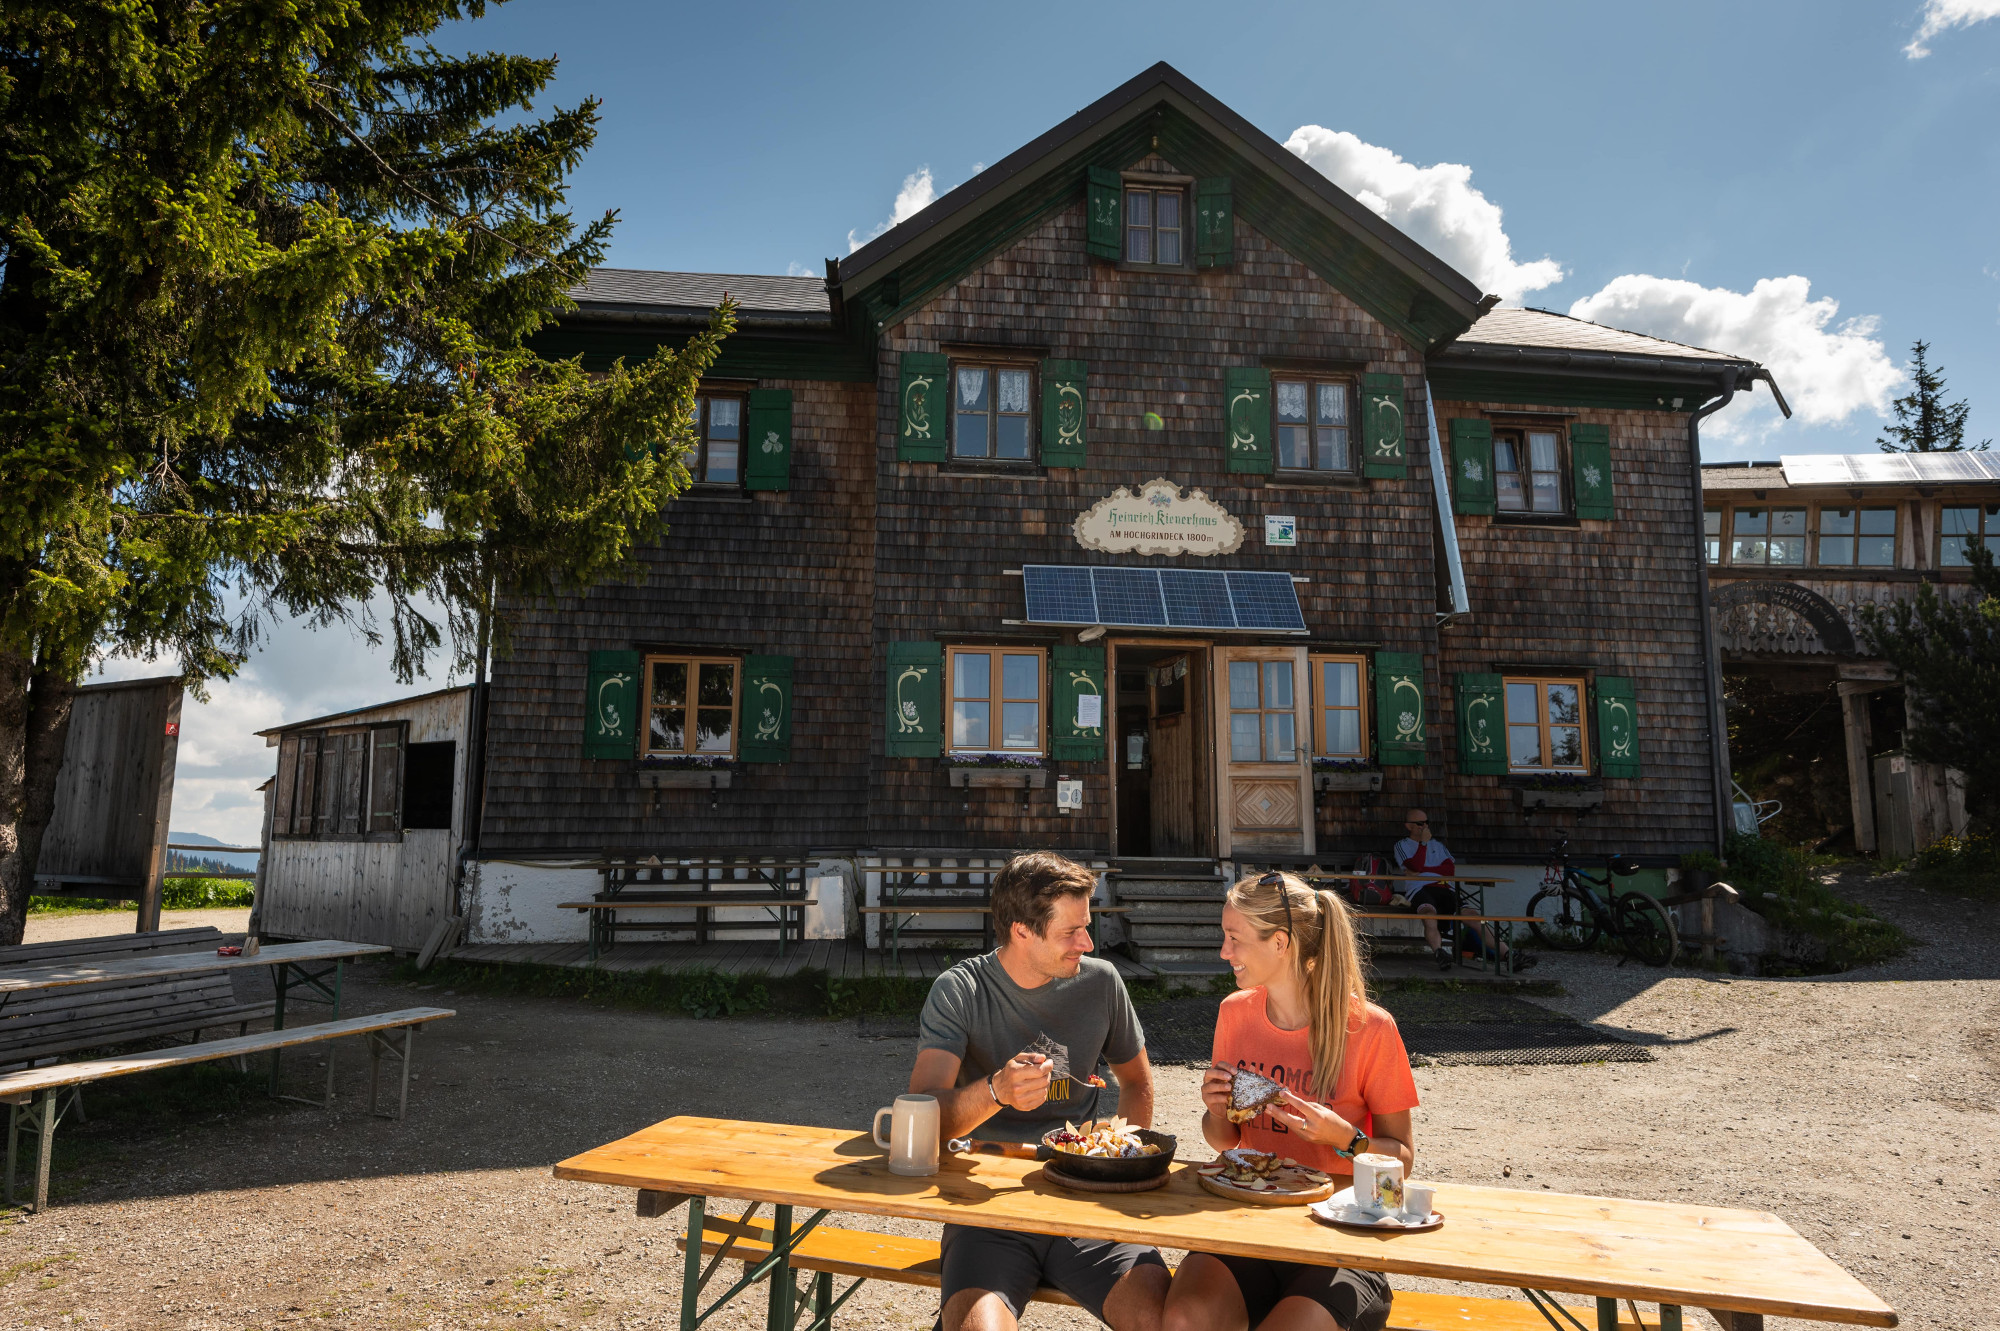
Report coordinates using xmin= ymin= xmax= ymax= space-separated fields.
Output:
xmin=254 ymin=64 xmax=1782 ymax=967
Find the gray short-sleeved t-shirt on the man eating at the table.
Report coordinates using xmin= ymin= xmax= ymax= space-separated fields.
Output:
xmin=918 ymin=951 xmax=1146 ymax=1141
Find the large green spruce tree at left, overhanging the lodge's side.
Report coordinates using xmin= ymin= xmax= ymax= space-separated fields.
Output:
xmin=0 ymin=0 xmax=732 ymax=943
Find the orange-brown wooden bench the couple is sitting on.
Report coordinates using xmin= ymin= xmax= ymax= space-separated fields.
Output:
xmin=672 ymin=1191 xmax=1658 ymax=1331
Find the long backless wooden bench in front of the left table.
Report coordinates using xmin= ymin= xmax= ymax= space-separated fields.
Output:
xmin=0 ymin=1007 xmax=458 ymax=1211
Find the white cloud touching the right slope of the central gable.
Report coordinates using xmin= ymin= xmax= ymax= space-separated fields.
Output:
xmin=1284 ymin=124 xmax=1564 ymax=306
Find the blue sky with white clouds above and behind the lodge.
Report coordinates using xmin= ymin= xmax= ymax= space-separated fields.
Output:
xmin=137 ymin=0 xmax=2000 ymax=839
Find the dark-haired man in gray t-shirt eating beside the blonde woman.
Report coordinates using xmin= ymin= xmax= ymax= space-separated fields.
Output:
xmin=910 ymin=851 xmax=1168 ymax=1331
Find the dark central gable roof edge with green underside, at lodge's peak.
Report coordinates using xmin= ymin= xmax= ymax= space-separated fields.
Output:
xmin=838 ymin=62 xmax=1484 ymax=348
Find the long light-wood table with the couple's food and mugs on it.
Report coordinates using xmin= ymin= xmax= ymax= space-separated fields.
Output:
xmin=556 ymin=1115 xmax=1896 ymax=1327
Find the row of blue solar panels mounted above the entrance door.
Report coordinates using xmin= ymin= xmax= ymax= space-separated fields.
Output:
xmin=1022 ymin=564 xmax=1306 ymax=634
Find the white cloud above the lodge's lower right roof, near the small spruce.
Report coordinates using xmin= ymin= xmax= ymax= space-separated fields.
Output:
xmin=1570 ymin=274 xmax=1904 ymax=442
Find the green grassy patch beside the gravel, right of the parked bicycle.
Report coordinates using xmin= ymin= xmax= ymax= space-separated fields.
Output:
xmin=1684 ymin=831 xmax=1910 ymax=975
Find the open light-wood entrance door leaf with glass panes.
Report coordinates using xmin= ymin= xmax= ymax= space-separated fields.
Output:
xmin=1212 ymin=648 xmax=1314 ymax=855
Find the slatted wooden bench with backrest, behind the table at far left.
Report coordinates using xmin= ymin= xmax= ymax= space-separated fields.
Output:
xmin=0 ymin=927 xmax=276 ymax=1067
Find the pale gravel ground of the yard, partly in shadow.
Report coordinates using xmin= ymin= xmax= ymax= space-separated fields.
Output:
xmin=0 ymin=877 xmax=2000 ymax=1331
